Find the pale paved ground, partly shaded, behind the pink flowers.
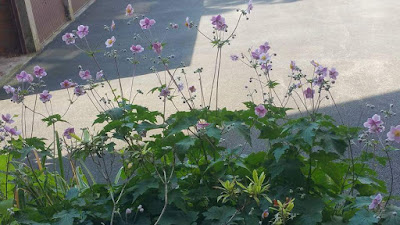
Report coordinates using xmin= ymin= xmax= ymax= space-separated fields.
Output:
xmin=0 ymin=0 xmax=400 ymax=193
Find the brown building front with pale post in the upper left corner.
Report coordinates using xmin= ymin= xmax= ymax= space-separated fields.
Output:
xmin=0 ymin=0 xmax=93 ymax=56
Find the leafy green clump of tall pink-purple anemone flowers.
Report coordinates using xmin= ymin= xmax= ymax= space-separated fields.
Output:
xmin=0 ymin=0 xmax=400 ymax=225
